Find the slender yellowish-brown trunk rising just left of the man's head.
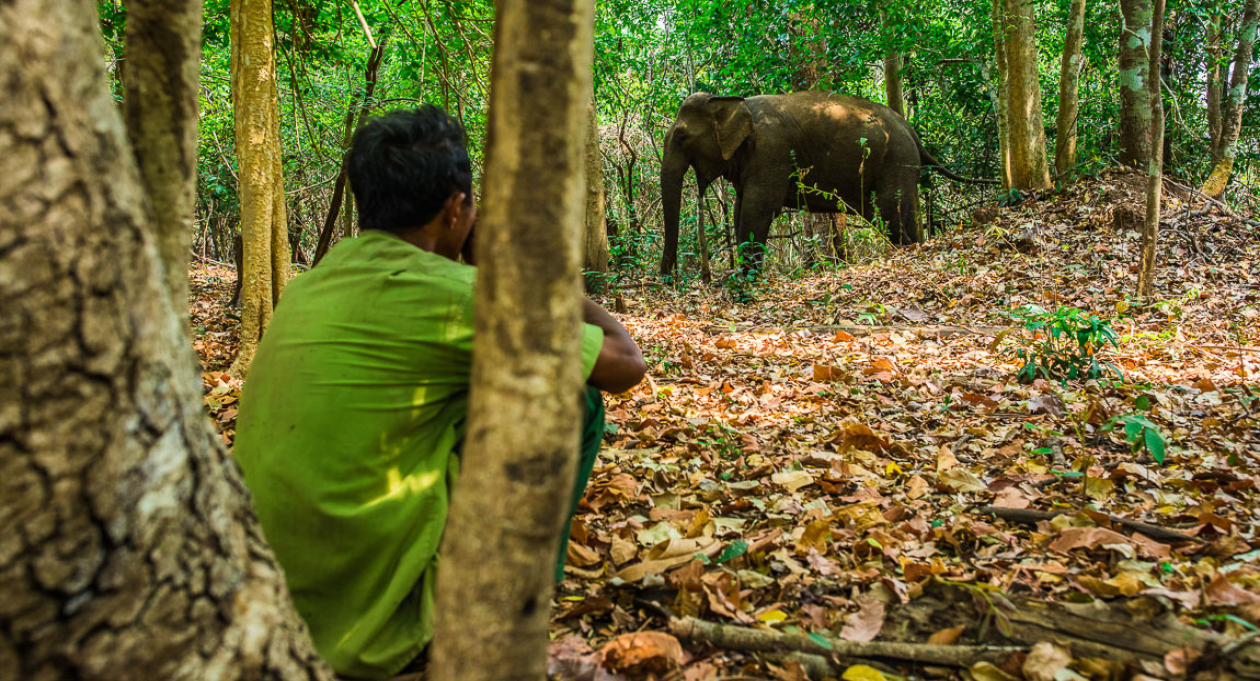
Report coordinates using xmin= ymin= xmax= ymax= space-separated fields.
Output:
xmin=231 ymin=0 xmax=289 ymax=376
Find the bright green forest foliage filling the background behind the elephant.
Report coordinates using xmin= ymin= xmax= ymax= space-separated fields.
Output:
xmin=91 ymin=0 xmax=1260 ymax=270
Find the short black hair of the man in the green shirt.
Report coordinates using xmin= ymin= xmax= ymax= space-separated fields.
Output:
xmin=347 ymin=105 xmax=473 ymax=232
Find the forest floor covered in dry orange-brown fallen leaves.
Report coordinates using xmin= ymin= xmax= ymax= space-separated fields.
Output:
xmin=192 ymin=167 xmax=1260 ymax=681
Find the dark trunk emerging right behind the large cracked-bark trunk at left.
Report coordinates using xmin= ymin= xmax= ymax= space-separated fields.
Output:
xmin=122 ymin=0 xmax=202 ymax=310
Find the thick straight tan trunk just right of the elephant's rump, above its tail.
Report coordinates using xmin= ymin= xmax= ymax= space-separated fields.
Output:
xmin=1002 ymin=0 xmax=1052 ymax=189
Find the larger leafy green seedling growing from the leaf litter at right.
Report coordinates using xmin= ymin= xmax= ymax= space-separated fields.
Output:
xmin=993 ymin=305 xmax=1124 ymax=383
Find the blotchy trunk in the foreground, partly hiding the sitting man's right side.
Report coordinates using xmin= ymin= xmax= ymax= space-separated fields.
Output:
xmin=432 ymin=0 xmax=595 ymax=681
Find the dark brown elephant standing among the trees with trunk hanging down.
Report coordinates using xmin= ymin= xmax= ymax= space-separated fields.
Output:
xmin=660 ymin=91 xmax=998 ymax=275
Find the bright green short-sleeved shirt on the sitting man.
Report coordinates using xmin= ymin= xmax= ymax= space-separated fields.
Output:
xmin=234 ymin=230 xmax=604 ymax=678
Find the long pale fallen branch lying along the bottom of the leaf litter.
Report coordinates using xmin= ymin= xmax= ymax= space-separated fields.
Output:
xmin=669 ymin=617 xmax=1027 ymax=667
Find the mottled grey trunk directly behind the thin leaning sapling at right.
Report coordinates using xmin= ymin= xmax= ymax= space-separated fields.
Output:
xmin=1119 ymin=0 xmax=1152 ymax=168
